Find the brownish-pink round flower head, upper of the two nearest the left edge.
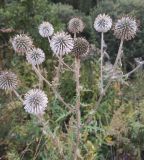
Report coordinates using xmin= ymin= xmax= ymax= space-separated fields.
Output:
xmin=11 ymin=34 xmax=33 ymax=54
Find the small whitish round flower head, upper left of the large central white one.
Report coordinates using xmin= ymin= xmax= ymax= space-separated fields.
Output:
xmin=39 ymin=22 xmax=54 ymax=37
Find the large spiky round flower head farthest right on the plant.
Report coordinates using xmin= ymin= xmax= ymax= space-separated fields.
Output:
xmin=114 ymin=16 xmax=138 ymax=41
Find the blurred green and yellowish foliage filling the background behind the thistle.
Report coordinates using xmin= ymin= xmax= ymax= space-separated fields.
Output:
xmin=0 ymin=0 xmax=144 ymax=160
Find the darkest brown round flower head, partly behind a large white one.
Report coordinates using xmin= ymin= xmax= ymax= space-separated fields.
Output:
xmin=72 ymin=38 xmax=89 ymax=56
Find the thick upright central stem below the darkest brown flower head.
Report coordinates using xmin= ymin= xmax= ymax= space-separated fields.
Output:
xmin=74 ymin=57 xmax=81 ymax=160
